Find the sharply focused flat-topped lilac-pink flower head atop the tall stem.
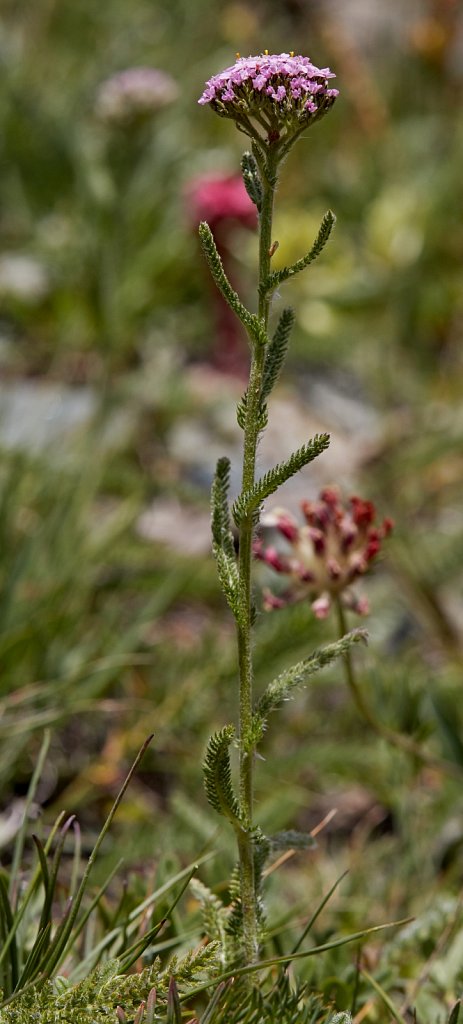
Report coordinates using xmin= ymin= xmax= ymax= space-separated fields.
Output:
xmin=199 ymin=50 xmax=338 ymax=144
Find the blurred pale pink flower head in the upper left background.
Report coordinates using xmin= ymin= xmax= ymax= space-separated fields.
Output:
xmin=95 ymin=68 xmax=179 ymax=127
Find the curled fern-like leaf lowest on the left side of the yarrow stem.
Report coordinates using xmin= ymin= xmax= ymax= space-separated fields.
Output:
xmin=203 ymin=725 xmax=243 ymax=828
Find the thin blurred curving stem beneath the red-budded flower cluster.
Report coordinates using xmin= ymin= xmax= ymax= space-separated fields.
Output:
xmin=336 ymin=598 xmax=462 ymax=779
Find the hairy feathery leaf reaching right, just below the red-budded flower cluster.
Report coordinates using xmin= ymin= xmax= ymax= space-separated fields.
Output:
xmin=255 ymin=629 xmax=368 ymax=731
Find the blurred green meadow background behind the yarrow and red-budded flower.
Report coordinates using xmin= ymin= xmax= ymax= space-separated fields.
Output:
xmin=0 ymin=0 xmax=463 ymax=1020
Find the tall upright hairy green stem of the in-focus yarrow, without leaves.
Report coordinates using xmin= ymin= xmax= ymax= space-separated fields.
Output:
xmin=238 ymin=148 xmax=278 ymax=964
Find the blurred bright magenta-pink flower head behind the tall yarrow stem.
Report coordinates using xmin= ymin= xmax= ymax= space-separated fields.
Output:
xmin=186 ymin=174 xmax=257 ymax=231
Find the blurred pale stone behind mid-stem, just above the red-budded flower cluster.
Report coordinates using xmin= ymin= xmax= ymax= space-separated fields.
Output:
xmin=168 ymin=367 xmax=382 ymax=506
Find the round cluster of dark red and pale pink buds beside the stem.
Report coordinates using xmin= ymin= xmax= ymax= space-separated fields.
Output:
xmin=254 ymin=487 xmax=392 ymax=618
